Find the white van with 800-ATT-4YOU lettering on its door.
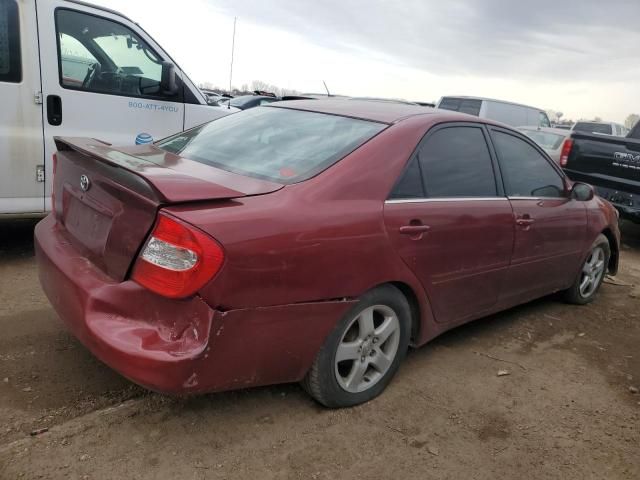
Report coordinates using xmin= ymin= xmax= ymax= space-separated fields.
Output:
xmin=0 ymin=0 xmax=235 ymax=216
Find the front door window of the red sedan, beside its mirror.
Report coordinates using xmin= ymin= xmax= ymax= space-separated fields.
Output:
xmin=492 ymin=131 xmax=565 ymax=198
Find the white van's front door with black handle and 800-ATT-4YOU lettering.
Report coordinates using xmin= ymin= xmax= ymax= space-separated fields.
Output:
xmin=38 ymin=0 xmax=185 ymax=210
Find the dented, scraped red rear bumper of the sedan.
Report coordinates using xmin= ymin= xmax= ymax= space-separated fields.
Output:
xmin=35 ymin=215 xmax=353 ymax=394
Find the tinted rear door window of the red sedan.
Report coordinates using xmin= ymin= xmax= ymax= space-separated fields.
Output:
xmin=418 ymin=127 xmax=497 ymax=198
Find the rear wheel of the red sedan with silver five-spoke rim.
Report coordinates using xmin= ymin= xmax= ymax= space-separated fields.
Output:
xmin=302 ymin=285 xmax=411 ymax=408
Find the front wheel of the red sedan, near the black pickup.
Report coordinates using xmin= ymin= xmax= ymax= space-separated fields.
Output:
xmin=564 ymin=234 xmax=611 ymax=305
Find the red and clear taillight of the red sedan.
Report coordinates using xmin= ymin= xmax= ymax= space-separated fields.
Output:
xmin=132 ymin=213 xmax=224 ymax=298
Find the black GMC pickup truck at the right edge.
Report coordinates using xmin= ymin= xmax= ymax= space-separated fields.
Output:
xmin=560 ymin=123 xmax=640 ymax=223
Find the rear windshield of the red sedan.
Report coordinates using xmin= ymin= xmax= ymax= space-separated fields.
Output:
xmin=157 ymin=107 xmax=386 ymax=184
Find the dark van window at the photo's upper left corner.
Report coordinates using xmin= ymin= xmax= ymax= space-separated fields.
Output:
xmin=0 ymin=0 xmax=22 ymax=83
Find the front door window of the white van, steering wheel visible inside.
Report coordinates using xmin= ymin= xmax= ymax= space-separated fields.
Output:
xmin=56 ymin=9 xmax=178 ymax=101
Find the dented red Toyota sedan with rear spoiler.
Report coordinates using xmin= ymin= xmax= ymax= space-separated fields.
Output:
xmin=36 ymin=100 xmax=620 ymax=407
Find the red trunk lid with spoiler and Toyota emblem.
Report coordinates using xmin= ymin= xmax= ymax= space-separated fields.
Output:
xmin=53 ymin=138 xmax=283 ymax=281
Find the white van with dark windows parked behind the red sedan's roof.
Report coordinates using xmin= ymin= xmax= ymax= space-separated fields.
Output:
xmin=436 ymin=97 xmax=551 ymax=128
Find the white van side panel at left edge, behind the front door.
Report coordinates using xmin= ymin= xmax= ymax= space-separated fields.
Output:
xmin=0 ymin=0 xmax=44 ymax=214
